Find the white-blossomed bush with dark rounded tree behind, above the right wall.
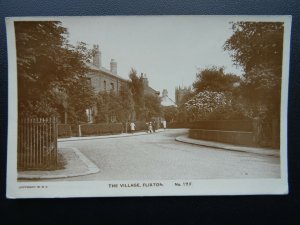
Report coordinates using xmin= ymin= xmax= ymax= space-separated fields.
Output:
xmin=177 ymin=67 xmax=244 ymax=122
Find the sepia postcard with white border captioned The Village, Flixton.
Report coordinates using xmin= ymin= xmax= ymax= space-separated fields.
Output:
xmin=6 ymin=16 xmax=291 ymax=198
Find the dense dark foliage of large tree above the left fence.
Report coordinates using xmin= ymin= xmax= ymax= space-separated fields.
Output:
xmin=15 ymin=21 xmax=93 ymax=120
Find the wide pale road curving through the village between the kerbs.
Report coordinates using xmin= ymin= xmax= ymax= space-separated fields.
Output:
xmin=59 ymin=130 xmax=280 ymax=180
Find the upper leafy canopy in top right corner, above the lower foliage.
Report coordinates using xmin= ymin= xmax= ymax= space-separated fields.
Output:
xmin=224 ymin=22 xmax=284 ymax=73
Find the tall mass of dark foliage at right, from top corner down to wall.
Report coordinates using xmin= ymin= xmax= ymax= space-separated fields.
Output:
xmin=224 ymin=22 xmax=284 ymax=117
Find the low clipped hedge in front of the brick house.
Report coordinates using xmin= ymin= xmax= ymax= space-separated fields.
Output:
xmin=81 ymin=123 xmax=123 ymax=136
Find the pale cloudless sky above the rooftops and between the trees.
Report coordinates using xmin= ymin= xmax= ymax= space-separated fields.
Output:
xmin=61 ymin=16 xmax=243 ymax=100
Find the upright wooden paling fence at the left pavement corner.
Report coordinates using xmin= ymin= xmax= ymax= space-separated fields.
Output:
xmin=17 ymin=118 xmax=57 ymax=170
